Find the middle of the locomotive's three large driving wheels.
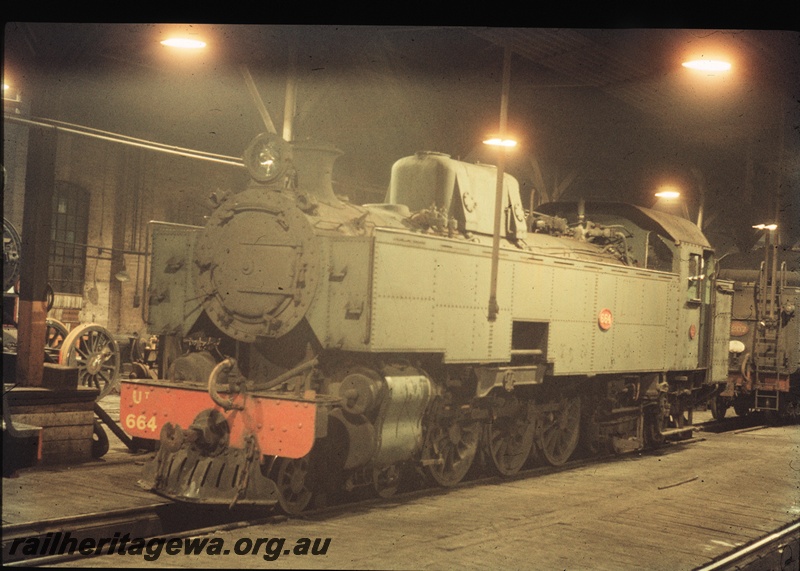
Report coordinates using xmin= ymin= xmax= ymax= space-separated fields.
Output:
xmin=486 ymin=408 xmax=533 ymax=476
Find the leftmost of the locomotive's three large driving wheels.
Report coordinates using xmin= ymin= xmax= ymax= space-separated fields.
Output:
xmin=423 ymin=402 xmax=480 ymax=486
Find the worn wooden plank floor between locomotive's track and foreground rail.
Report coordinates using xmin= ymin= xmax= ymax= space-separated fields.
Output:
xmin=25 ymin=412 xmax=800 ymax=571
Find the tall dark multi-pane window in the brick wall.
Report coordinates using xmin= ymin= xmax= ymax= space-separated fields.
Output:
xmin=47 ymin=181 xmax=89 ymax=294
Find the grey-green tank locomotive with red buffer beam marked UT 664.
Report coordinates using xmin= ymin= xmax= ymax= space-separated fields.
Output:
xmin=121 ymin=135 xmax=731 ymax=513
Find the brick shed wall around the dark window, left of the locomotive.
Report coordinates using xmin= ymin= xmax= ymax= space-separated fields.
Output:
xmin=3 ymin=124 xmax=247 ymax=344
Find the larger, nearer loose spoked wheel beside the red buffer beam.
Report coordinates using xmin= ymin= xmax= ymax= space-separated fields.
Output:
xmin=58 ymin=323 xmax=120 ymax=401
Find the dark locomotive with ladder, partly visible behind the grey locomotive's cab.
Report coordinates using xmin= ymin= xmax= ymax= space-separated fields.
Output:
xmin=711 ymin=235 xmax=800 ymax=422
